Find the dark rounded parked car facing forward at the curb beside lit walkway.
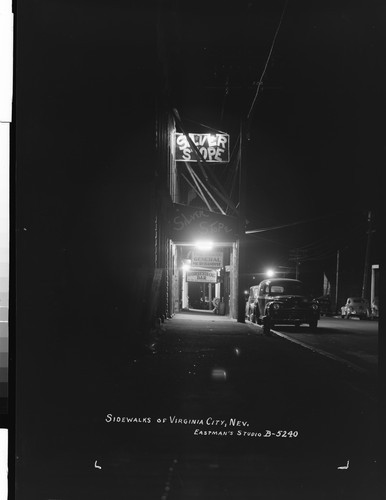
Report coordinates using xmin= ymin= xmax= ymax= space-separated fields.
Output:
xmin=246 ymin=278 xmax=320 ymax=335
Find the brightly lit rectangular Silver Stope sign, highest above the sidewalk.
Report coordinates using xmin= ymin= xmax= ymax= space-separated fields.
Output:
xmin=174 ymin=132 xmax=229 ymax=163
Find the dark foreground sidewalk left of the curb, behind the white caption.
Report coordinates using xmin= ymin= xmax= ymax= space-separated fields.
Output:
xmin=18 ymin=312 xmax=386 ymax=500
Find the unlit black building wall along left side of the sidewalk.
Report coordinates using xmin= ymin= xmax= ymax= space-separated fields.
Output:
xmin=11 ymin=1 xmax=161 ymax=463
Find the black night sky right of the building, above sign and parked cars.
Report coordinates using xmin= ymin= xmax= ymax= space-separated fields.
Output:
xmin=162 ymin=0 xmax=384 ymax=287
